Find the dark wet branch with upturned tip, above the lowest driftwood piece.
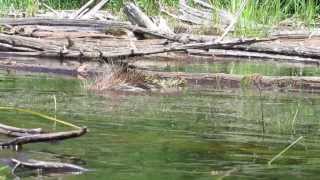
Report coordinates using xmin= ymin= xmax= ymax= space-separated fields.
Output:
xmin=0 ymin=127 xmax=87 ymax=147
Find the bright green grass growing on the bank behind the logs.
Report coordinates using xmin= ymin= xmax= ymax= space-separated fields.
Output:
xmin=0 ymin=0 xmax=320 ymax=35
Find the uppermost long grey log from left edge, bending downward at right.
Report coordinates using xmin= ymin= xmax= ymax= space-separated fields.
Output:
xmin=0 ymin=18 xmax=216 ymax=43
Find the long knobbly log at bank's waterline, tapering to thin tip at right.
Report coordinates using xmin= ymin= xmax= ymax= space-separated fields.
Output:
xmin=0 ymin=34 xmax=272 ymax=59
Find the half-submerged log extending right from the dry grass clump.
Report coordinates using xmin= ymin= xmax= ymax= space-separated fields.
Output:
xmin=148 ymin=71 xmax=320 ymax=93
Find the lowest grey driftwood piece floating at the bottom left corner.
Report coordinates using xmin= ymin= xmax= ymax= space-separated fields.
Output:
xmin=11 ymin=159 xmax=89 ymax=174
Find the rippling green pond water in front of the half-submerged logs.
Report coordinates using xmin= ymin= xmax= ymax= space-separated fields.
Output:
xmin=0 ymin=60 xmax=320 ymax=180
